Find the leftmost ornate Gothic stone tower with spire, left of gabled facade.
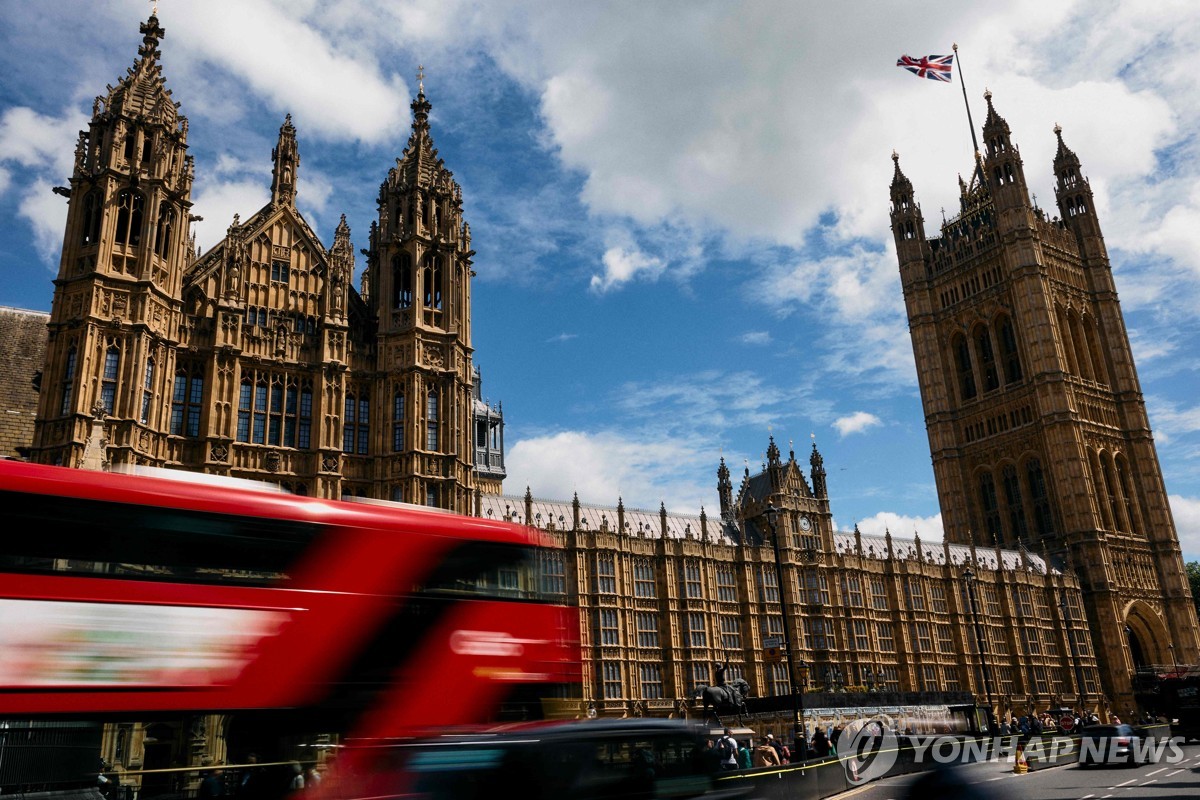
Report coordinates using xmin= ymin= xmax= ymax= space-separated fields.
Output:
xmin=31 ymin=16 xmax=193 ymax=467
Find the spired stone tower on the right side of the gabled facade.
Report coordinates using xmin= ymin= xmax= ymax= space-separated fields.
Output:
xmin=362 ymin=84 xmax=477 ymax=512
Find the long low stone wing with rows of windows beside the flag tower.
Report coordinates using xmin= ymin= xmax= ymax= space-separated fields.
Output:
xmin=482 ymin=440 xmax=1099 ymax=728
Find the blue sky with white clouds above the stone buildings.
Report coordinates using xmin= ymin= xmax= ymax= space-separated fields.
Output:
xmin=0 ymin=0 xmax=1200 ymax=558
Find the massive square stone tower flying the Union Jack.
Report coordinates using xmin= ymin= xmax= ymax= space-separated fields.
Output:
xmin=892 ymin=94 xmax=1200 ymax=711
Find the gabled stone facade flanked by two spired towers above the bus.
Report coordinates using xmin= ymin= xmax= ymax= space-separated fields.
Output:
xmin=28 ymin=16 xmax=504 ymax=513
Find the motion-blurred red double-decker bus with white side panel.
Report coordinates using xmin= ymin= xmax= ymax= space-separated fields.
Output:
xmin=0 ymin=461 xmax=580 ymax=777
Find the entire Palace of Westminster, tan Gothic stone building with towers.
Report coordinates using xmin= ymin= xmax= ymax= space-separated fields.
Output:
xmin=0 ymin=9 xmax=1200 ymax=766
